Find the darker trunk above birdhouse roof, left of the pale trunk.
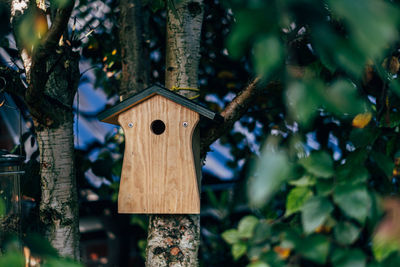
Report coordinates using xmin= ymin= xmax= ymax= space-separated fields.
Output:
xmin=118 ymin=0 xmax=150 ymax=100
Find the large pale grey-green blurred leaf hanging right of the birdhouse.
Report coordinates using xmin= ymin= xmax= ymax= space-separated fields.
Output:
xmin=247 ymin=148 xmax=291 ymax=207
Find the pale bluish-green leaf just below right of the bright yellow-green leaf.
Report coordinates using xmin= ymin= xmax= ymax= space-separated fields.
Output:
xmin=301 ymin=197 xmax=333 ymax=233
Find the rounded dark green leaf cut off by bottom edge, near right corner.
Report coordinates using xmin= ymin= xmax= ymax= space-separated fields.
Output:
xmin=332 ymin=249 xmax=367 ymax=267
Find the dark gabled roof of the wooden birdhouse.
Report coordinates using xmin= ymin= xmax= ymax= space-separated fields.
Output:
xmin=97 ymin=85 xmax=222 ymax=124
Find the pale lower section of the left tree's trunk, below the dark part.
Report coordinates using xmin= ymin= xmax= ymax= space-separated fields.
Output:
xmin=37 ymin=119 xmax=79 ymax=259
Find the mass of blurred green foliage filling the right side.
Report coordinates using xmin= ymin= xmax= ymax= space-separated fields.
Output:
xmin=222 ymin=0 xmax=400 ymax=266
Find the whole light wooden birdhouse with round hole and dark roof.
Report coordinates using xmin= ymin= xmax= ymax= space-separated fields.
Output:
xmin=98 ymin=85 xmax=221 ymax=214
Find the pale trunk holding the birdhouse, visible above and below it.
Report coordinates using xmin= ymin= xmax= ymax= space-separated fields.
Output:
xmin=146 ymin=0 xmax=203 ymax=267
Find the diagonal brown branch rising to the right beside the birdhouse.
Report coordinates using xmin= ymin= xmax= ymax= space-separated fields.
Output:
xmin=200 ymin=77 xmax=280 ymax=158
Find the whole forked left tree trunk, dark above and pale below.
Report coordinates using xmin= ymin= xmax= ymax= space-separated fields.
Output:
xmin=8 ymin=0 xmax=80 ymax=259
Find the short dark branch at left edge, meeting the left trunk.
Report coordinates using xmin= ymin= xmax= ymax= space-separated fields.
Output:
xmin=0 ymin=66 xmax=26 ymax=98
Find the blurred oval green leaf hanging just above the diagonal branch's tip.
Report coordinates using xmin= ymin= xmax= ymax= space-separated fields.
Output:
xmin=253 ymin=35 xmax=283 ymax=75
